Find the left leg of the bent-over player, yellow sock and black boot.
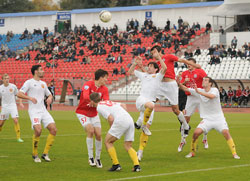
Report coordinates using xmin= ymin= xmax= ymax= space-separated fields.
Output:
xmin=105 ymin=133 xmax=121 ymax=171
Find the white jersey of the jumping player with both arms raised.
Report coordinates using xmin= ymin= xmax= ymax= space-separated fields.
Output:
xmin=134 ymin=70 xmax=164 ymax=101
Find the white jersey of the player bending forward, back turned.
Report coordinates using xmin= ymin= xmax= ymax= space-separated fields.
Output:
xmin=96 ymin=100 xmax=130 ymax=121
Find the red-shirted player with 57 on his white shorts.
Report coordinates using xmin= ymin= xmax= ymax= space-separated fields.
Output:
xmin=76 ymin=69 xmax=109 ymax=168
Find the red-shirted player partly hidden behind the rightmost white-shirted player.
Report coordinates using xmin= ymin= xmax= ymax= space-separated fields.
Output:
xmin=178 ymin=58 xmax=208 ymax=152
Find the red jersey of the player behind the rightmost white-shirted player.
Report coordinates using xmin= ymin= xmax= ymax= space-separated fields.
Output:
xmin=181 ymin=69 xmax=207 ymax=95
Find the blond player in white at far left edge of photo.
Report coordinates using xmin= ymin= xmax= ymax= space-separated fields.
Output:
xmin=0 ymin=74 xmax=23 ymax=143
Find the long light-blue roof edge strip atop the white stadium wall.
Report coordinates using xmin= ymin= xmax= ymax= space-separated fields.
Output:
xmin=0 ymin=1 xmax=223 ymax=18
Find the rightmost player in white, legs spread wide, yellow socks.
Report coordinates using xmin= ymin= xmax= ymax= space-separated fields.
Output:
xmin=180 ymin=77 xmax=240 ymax=159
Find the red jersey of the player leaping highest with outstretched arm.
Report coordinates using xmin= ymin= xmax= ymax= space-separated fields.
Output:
xmin=157 ymin=54 xmax=179 ymax=80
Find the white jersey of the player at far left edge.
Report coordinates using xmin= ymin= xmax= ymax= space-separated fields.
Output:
xmin=0 ymin=83 xmax=18 ymax=107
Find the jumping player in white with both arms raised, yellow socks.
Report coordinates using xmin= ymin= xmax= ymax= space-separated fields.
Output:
xmin=128 ymin=53 xmax=167 ymax=161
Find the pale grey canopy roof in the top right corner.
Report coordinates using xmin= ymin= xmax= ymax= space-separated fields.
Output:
xmin=209 ymin=1 xmax=250 ymax=16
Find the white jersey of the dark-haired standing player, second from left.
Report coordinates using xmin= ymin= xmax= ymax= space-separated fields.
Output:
xmin=20 ymin=79 xmax=51 ymax=112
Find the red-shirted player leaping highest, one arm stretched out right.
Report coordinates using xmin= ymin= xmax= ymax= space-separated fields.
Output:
xmin=151 ymin=45 xmax=201 ymax=141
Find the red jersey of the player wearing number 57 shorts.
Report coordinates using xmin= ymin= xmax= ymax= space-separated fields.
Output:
xmin=76 ymin=81 xmax=109 ymax=117
